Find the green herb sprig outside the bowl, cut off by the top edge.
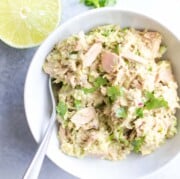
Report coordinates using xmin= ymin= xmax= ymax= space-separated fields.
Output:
xmin=80 ymin=0 xmax=116 ymax=8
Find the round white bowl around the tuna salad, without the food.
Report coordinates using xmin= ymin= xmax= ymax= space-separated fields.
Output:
xmin=24 ymin=8 xmax=180 ymax=179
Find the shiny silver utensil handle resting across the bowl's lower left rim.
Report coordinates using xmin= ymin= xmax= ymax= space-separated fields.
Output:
xmin=23 ymin=112 xmax=56 ymax=179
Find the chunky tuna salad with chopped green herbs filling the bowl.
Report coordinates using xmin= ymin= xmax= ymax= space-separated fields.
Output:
xmin=43 ymin=25 xmax=179 ymax=160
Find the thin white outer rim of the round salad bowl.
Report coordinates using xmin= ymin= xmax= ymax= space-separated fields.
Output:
xmin=23 ymin=7 xmax=180 ymax=177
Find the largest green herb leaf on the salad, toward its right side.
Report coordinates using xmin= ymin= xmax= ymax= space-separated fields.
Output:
xmin=145 ymin=92 xmax=168 ymax=110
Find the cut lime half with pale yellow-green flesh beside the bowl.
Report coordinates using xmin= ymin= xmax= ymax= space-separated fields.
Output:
xmin=0 ymin=0 xmax=61 ymax=48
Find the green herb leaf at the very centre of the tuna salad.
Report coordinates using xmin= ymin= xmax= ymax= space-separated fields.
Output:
xmin=107 ymin=86 xmax=123 ymax=101
